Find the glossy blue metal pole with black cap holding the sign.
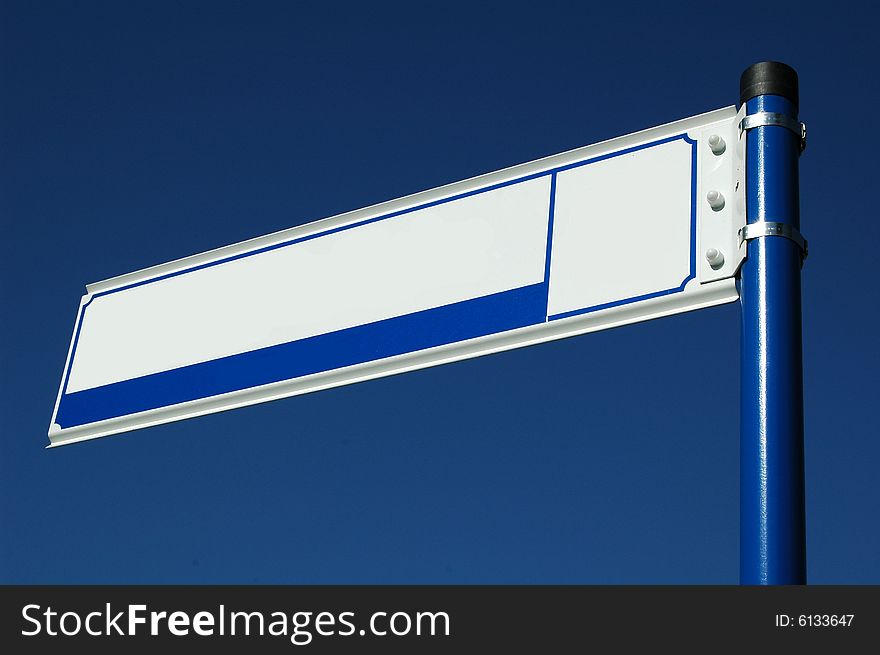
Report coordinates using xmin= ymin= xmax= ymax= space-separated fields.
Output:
xmin=740 ymin=62 xmax=806 ymax=585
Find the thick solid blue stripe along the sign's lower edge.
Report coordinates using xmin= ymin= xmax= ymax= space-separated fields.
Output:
xmin=57 ymin=283 xmax=547 ymax=428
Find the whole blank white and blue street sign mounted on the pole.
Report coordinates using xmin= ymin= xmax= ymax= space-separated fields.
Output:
xmin=49 ymin=107 xmax=745 ymax=446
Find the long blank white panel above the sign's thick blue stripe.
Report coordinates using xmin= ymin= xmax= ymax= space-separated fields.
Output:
xmin=68 ymin=177 xmax=550 ymax=392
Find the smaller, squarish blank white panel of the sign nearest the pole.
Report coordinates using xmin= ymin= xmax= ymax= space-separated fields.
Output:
xmin=550 ymin=139 xmax=693 ymax=316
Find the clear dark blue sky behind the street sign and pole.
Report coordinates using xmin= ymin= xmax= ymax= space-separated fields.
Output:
xmin=0 ymin=0 xmax=880 ymax=583
